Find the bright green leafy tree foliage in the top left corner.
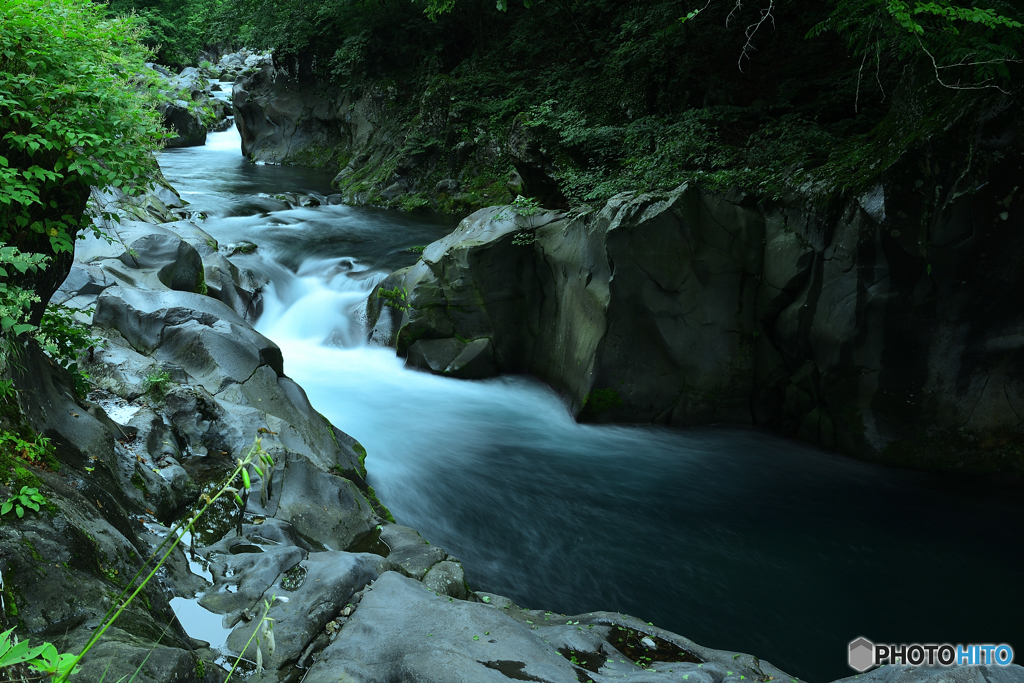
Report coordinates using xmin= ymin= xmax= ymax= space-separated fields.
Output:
xmin=0 ymin=0 xmax=164 ymax=318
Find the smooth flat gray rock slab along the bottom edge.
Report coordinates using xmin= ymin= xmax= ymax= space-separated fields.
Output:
xmin=303 ymin=571 xmax=788 ymax=683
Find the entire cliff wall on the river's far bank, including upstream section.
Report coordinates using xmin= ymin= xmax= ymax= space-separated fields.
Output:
xmin=234 ymin=53 xmax=1024 ymax=471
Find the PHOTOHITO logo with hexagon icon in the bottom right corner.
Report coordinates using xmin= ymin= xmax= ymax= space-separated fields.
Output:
xmin=849 ymin=638 xmax=1014 ymax=673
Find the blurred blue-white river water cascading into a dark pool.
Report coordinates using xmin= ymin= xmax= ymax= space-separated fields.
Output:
xmin=160 ymin=120 xmax=1024 ymax=681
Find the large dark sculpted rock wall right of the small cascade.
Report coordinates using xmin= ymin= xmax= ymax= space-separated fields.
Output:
xmin=391 ymin=180 xmax=1024 ymax=471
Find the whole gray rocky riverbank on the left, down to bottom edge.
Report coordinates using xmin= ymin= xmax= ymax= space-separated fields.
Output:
xmin=0 ymin=181 xmax=811 ymax=683
